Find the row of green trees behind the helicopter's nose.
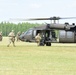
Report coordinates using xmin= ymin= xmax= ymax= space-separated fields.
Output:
xmin=0 ymin=22 xmax=40 ymax=36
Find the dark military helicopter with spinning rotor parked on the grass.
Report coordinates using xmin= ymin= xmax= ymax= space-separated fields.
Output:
xmin=16 ymin=17 xmax=76 ymax=46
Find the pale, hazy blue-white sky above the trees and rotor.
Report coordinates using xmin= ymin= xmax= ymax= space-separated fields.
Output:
xmin=0 ymin=0 xmax=76 ymax=23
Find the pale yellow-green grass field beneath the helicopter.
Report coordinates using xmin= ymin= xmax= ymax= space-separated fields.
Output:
xmin=0 ymin=37 xmax=76 ymax=75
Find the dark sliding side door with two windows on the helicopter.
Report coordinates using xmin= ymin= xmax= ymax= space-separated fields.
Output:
xmin=59 ymin=30 xmax=75 ymax=43
